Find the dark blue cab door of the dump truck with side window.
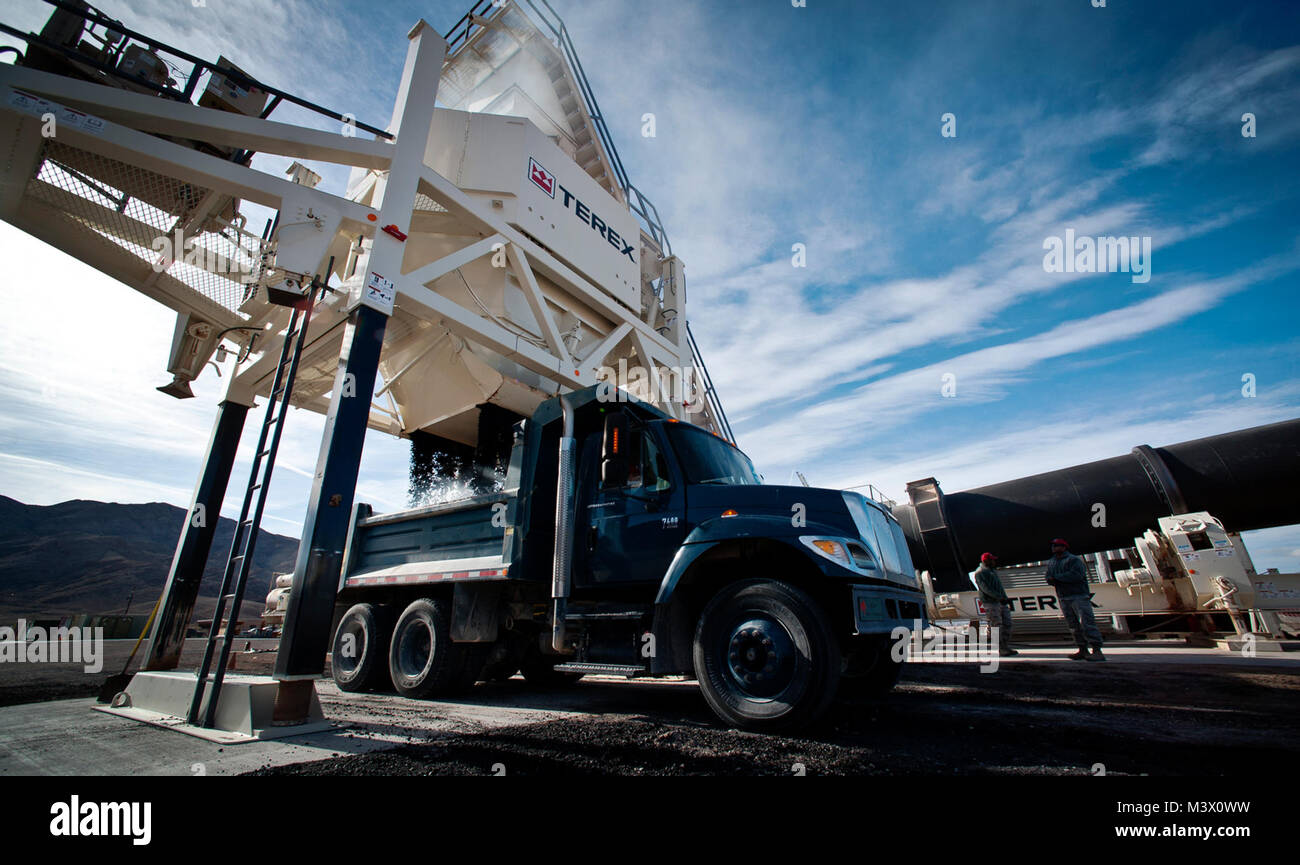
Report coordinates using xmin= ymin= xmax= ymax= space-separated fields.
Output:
xmin=576 ymin=427 xmax=686 ymax=585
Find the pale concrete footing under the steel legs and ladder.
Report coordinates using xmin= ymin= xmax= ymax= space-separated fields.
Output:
xmin=95 ymin=671 xmax=332 ymax=744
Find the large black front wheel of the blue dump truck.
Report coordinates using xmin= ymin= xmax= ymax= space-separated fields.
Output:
xmin=694 ymin=580 xmax=840 ymax=731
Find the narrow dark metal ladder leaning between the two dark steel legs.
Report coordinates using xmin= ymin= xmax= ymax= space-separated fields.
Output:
xmin=189 ymin=284 xmax=319 ymax=728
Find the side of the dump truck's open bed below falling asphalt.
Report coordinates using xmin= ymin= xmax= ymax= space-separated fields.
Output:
xmin=339 ymin=493 xmax=514 ymax=589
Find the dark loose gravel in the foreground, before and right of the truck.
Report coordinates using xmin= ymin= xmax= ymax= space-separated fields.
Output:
xmin=245 ymin=661 xmax=1300 ymax=775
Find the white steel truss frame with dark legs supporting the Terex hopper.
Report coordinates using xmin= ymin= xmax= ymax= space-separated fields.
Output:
xmin=0 ymin=10 xmax=722 ymax=702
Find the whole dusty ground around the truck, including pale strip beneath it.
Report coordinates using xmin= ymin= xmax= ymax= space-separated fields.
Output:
xmin=0 ymin=641 xmax=1300 ymax=775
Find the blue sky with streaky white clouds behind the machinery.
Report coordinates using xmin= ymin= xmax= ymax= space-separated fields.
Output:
xmin=0 ymin=0 xmax=1300 ymax=571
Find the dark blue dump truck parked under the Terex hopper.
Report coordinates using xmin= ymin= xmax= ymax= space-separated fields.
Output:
xmin=332 ymin=386 xmax=924 ymax=730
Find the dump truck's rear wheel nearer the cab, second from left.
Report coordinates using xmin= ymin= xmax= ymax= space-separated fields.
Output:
xmin=389 ymin=598 xmax=473 ymax=700
